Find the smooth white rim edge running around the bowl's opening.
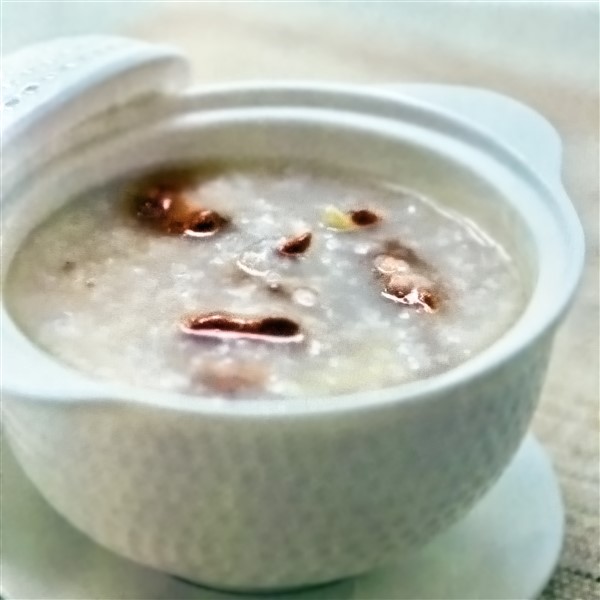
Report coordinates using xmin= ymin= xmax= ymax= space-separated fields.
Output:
xmin=0 ymin=81 xmax=584 ymax=418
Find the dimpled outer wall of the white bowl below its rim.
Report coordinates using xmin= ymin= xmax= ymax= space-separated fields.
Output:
xmin=6 ymin=346 xmax=546 ymax=589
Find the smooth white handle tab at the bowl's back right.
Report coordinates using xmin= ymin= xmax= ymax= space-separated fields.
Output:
xmin=386 ymin=84 xmax=562 ymax=183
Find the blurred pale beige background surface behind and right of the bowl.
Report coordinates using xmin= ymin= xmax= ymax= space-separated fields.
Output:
xmin=1 ymin=0 xmax=600 ymax=600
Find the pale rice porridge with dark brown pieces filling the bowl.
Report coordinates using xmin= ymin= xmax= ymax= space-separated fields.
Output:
xmin=7 ymin=164 xmax=525 ymax=398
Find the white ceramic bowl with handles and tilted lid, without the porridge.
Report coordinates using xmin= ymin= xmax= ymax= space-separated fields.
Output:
xmin=2 ymin=38 xmax=583 ymax=590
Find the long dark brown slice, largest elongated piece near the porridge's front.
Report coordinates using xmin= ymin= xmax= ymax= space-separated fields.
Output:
xmin=180 ymin=313 xmax=304 ymax=344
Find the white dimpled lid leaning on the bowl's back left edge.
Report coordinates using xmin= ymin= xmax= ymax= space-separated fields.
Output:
xmin=0 ymin=36 xmax=190 ymax=185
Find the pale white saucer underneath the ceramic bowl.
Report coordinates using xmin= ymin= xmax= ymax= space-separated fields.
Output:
xmin=0 ymin=435 xmax=563 ymax=600
